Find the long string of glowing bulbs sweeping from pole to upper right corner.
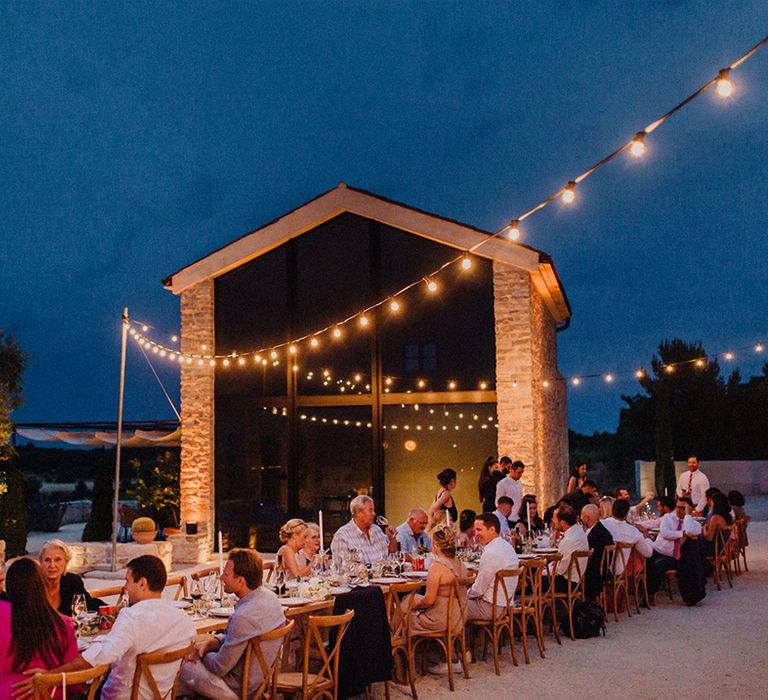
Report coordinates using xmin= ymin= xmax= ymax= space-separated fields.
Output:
xmin=124 ymin=37 xmax=768 ymax=366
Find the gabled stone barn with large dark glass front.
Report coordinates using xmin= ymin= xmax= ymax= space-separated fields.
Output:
xmin=164 ymin=184 xmax=570 ymax=549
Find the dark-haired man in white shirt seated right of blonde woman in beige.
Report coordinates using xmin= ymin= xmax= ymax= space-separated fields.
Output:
xmin=467 ymin=513 xmax=519 ymax=620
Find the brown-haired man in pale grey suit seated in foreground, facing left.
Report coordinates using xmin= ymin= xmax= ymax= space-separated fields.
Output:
xmin=178 ymin=549 xmax=285 ymax=699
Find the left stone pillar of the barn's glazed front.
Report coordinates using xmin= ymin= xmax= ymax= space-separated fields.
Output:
xmin=181 ymin=280 xmax=215 ymax=551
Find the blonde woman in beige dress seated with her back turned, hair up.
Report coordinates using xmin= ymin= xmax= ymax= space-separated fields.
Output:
xmin=403 ymin=525 xmax=467 ymax=634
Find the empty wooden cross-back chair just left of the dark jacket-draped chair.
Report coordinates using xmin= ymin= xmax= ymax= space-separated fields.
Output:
xmin=275 ymin=610 xmax=355 ymax=700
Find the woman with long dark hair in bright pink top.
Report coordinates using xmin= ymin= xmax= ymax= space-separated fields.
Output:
xmin=0 ymin=557 xmax=78 ymax=698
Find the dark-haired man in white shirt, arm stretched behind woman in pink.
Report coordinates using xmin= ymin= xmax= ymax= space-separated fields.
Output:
xmin=15 ymin=554 xmax=195 ymax=700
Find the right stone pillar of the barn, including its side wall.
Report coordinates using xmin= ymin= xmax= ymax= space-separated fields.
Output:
xmin=493 ymin=262 xmax=568 ymax=507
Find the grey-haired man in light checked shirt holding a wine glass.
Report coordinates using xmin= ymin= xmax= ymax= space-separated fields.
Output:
xmin=331 ymin=496 xmax=397 ymax=564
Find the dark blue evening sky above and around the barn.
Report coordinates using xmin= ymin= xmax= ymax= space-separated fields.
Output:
xmin=0 ymin=0 xmax=768 ymax=431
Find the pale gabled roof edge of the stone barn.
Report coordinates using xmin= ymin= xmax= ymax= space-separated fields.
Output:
xmin=163 ymin=182 xmax=571 ymax=323
